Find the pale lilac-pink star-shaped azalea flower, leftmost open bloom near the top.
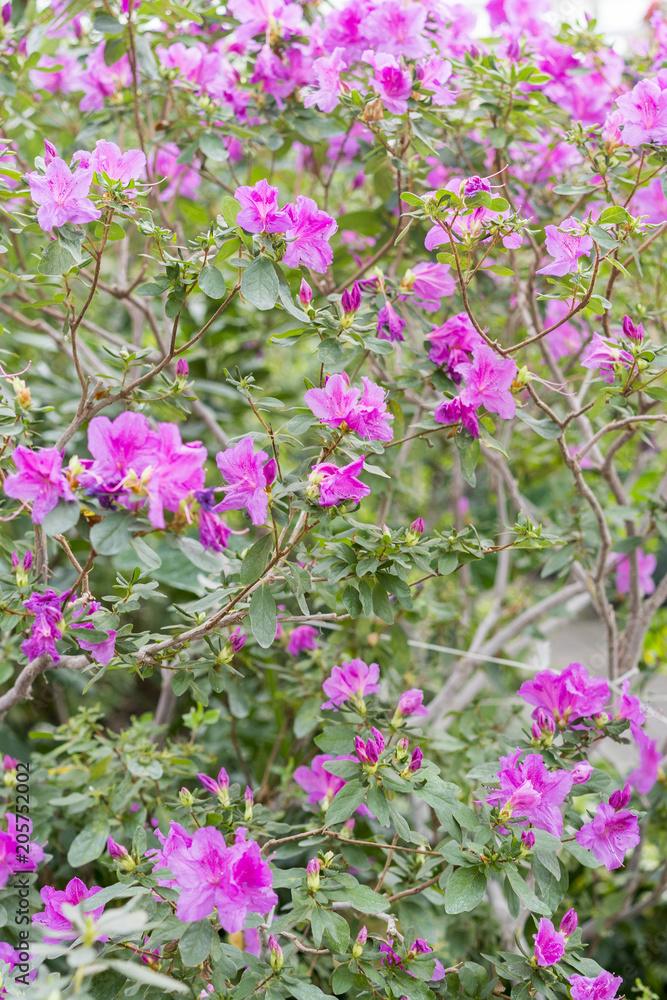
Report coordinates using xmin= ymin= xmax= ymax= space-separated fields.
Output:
xmin=26 ymin=156 xmax=102 ymax=232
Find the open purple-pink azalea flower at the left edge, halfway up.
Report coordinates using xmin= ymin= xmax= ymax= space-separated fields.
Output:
xmin=3 ymin=445 xmax=76 ymax=524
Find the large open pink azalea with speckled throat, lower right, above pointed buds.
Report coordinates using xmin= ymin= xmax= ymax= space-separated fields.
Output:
xmin=486 ymin=747 xmax=573 ymax=837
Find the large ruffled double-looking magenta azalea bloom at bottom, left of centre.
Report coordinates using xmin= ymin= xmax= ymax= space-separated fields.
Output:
xmin=169 ymin=826 xmax=278 ymax=934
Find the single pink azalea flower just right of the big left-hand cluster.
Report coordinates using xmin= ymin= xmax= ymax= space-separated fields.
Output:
xmin=215 ymin=438 xmax=276 ymax=525
